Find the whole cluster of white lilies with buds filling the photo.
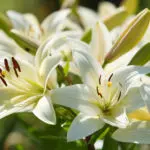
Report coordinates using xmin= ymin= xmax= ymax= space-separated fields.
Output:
xmin=0 ymin=1 xmax=150 ymax=148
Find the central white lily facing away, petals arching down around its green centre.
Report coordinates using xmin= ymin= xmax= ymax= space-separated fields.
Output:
xmin=36 ymin=32 xmax=89 ymax=75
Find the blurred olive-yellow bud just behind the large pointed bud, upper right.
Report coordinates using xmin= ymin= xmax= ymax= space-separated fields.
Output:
xmin=103 ymin=7 xmax=128 ymax=30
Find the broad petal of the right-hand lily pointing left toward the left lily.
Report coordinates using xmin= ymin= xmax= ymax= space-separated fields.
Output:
xmin=51 ymin=85 xmax=100 ymax=116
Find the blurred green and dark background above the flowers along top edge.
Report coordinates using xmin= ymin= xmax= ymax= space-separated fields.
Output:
xmin=0 ymin=0 xmax=150 ymax=20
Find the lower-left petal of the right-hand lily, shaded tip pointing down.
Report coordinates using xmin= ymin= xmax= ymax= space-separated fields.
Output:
xmin=67 ymin=114 xmax=105 ymax=142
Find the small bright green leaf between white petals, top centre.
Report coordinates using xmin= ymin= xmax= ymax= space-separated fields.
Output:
xmin=81 ymin=29 xmax=92 ymax=44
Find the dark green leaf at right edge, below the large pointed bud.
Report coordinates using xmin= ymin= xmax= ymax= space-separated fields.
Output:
xmin=129 ymin=43 xmax=150 ymax=66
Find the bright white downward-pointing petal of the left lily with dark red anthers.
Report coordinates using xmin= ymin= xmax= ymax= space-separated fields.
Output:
xmin=33 ymin=95 xmax=56 ymax=125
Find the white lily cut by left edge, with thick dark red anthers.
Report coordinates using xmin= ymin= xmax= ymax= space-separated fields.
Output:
xmin=0 ymin=39 xmax=61 ymax=124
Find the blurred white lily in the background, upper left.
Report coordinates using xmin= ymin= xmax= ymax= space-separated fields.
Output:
xmin=7 ymin=9 xmax=86 ymax=43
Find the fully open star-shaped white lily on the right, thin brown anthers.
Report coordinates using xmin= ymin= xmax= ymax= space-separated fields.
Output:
xmin=51 ymin=48 xmax=150 ymax=141
